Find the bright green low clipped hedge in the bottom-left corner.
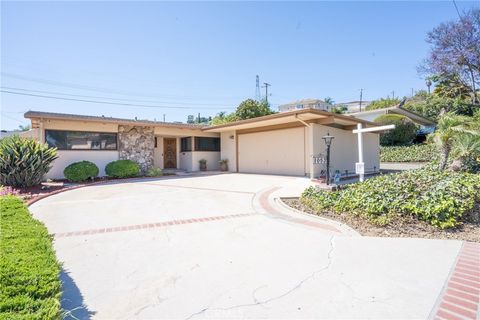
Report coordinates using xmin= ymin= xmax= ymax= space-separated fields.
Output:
xmin=0 ymin=196 xmax=61 ymax=319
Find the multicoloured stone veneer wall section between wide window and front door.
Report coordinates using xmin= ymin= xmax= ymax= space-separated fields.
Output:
xmin=118 ymin=125 xmax=155 ymax=174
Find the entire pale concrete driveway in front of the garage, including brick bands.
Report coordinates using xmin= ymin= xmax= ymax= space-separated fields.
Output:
xmin=30 ymin=174 xmax=478 ymax=319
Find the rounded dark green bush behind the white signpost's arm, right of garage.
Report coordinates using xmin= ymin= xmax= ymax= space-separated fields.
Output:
xmin=374 ymin=114 xmax=418 ymax=146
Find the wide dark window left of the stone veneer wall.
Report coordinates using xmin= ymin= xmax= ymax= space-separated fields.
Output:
xmin=45 ymin=130 xmax=117 ymax=150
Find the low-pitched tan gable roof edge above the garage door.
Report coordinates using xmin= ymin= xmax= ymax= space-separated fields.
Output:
xmin=203 ymin=108 xmax=377 ymax=132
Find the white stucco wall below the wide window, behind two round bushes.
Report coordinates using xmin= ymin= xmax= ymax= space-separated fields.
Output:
xmin=46 ymin=150 xmax=118 ymax=179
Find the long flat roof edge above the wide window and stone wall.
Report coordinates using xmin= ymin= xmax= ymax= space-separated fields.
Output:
xmin=24 ymin=111 xmax=205 ymax=129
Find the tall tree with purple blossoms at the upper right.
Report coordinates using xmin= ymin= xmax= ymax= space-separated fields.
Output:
xmin=420 ymin=9 xmax=480 ymax=104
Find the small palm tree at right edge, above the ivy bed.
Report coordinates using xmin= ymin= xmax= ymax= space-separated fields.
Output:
xmin=429 ymin=112 xmax=480 ymax=170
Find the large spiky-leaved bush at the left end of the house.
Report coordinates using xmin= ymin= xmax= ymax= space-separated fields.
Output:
xmin=0 ymin=136 xmax=57 ymax=187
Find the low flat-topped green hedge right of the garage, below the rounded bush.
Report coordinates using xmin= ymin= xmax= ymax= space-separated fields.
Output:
xmin=380 ymin=143 xmax=439 ymax=162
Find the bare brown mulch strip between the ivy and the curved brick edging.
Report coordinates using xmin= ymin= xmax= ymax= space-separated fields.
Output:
xmin=282 ymin=198 xmax=480 ymax=242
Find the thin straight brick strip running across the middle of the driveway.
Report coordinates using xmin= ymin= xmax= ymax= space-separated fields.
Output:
xmin=54 ymin=213 xmax=258 ymax=238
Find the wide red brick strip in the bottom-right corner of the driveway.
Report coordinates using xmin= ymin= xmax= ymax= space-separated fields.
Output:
xmin=431 ymin=242 xmax=480 ymax=320
